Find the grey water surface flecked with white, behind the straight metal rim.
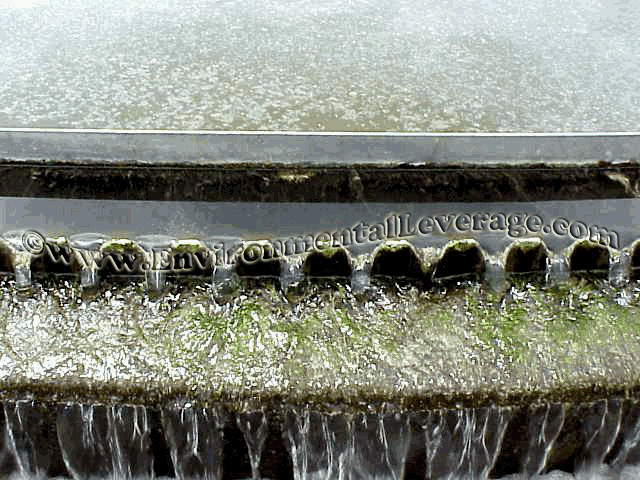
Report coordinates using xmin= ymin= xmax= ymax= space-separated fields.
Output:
xmin=0 ymin=0 xmax=640 ymax=132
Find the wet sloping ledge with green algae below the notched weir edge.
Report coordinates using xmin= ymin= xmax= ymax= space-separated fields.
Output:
xmin=0 ymin=279 xmax=640 ymax=404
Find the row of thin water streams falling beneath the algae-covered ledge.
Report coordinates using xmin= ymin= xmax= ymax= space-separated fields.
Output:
xmin=5 ymin=398 xmax=640 ymax=480
